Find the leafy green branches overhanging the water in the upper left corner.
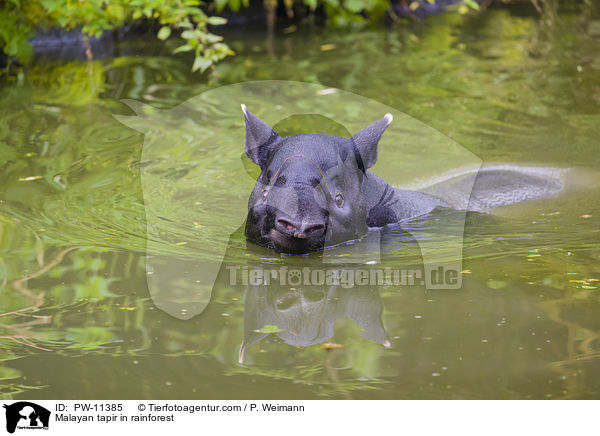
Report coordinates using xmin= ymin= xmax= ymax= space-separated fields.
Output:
xmin=0 ymin=0 xmax=233 ymax=71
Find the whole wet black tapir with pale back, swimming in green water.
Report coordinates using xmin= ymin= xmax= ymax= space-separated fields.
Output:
xmin=242 ymin=105 xmax=563 ymax=254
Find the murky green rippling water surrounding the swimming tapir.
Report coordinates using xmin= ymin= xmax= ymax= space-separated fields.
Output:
xmin=0 ymin=5 xmax=600 ymax=399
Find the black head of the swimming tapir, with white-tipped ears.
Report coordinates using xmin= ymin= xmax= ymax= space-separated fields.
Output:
xmin=242 ymin=105 xmax=392 ymax=254
